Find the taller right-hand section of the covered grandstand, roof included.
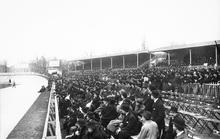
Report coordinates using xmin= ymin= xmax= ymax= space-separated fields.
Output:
xmin=151 ymin=40 xmax=220 ymax=66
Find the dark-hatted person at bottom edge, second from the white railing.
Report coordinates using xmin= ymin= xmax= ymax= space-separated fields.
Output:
xmin=86 ymin=121 xmax=105 ymax=139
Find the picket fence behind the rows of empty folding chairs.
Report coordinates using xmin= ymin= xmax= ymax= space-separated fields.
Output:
xmin=163 ymin=83 xmax=220 ymax=99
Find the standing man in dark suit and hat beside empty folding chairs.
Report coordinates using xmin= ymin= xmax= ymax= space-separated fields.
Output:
xmin=151 ymin=90 xmax=165 ymax=136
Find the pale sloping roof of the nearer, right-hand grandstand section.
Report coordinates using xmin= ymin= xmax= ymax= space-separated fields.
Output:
xmin=150 ymin=40 xmax=220 ymax=52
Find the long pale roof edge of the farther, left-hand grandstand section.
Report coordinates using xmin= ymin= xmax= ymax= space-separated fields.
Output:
xmin=69 ymin=50 xmax=149 ymax=62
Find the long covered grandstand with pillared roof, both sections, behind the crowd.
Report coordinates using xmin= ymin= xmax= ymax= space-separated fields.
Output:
xmin=69 ymin=40 xmax=220 ymax=71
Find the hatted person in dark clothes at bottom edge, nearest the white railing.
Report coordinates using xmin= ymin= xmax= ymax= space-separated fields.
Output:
xmin=65 ymin=119 xmax=87 ymax=139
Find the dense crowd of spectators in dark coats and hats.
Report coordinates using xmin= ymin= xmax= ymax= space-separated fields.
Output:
xmin=52 ymin=63 xmax=220 ymax=139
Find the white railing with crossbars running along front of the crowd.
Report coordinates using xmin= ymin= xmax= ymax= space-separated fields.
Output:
xmin=42 ymin=82 xmax=62 ymax=139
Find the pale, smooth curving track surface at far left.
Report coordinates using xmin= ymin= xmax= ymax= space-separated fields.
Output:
xmin=0 ymin=75 xmax=47 ymax=139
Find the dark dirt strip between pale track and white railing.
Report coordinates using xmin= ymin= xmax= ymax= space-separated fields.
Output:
xmin=7 ymin=91 xmax=50 ymax=139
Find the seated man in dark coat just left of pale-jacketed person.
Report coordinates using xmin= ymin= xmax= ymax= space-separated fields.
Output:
xmin=116 ymin=104 xmax=140 ymax=139
